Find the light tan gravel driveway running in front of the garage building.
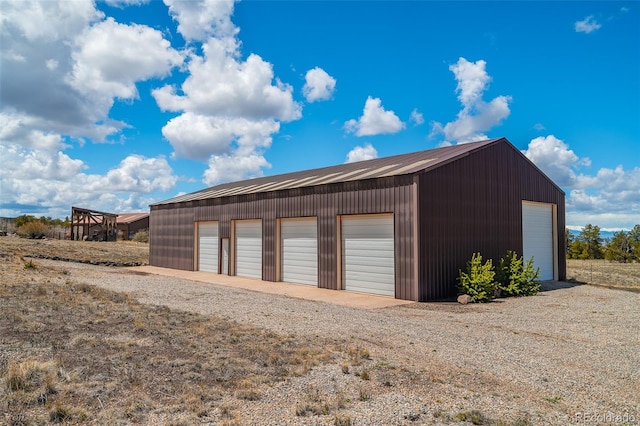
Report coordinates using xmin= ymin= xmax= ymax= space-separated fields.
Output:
xmin=42 ymin=261 xmax=640 ymax=425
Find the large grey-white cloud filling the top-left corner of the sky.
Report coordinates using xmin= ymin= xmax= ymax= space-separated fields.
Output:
xmin=0 ymin=0 xmax=182 ymax=142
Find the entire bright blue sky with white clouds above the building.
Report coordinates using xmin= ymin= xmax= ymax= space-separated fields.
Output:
xmin=0 ymin=0 xmax=640 ymax=229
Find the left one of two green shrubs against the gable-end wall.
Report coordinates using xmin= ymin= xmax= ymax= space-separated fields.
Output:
xmin=458 ymin=253 xmax=498 ymax=302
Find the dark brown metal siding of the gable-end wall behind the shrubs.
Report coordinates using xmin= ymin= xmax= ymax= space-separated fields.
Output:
xmin=418 ymin=143 xmax=566 ymax=301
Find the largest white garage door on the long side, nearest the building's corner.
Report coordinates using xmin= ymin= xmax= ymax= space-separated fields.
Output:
xmin=342 ymin=215 xmax=395 ymax=296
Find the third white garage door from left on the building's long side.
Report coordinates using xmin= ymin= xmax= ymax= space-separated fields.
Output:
xmin=280 ymin=218 xmax=318 ymax=286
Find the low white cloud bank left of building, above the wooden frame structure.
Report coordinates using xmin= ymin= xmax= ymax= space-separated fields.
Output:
xmin=0 ymin=135 xmax=177 ymax=216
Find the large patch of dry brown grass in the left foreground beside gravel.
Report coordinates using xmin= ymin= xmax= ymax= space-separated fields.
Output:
xmin=0 ymin=238 xmax=334 ymax=424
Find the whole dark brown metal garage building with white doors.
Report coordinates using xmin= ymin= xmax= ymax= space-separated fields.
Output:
xmin=150 ymin=138 xmax=566 ymax=301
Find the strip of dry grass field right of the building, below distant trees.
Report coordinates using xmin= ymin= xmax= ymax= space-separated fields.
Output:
xmin=567 ymin=259 xmax=640 ymax=291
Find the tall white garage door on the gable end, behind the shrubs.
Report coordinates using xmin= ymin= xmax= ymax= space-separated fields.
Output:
xmin=522 ymin=203 xmax=553 ymax=280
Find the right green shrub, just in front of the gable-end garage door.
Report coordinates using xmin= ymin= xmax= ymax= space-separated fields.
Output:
xmin=496 ymin=250 xmax=540 ymax=297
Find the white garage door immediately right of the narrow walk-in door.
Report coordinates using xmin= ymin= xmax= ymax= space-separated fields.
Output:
xmin=236 ymin=220 xmax=262 ymax=279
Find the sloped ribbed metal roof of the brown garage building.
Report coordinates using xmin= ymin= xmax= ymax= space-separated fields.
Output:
xmin=152 ymin=138 xmax=508 ymax=206
